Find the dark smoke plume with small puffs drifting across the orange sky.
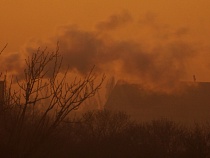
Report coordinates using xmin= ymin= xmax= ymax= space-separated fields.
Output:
xmin=6 ymin=13 xmax=196 ymax=89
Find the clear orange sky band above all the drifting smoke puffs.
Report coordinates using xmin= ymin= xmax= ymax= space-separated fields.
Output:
xmin=0 ymin=0 xmax=210 ymax=50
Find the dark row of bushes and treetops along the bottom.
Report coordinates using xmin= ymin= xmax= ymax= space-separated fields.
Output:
xmin=0 ymin=110 xmax=210 ymax=158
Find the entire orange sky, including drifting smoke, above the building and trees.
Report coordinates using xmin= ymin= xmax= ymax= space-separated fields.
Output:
xmin=0 ymin=0 xmax=210 ymax=86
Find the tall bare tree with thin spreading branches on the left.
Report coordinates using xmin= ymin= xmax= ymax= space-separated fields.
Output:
xmin=6 ymin=45 xmax=105 ymax=157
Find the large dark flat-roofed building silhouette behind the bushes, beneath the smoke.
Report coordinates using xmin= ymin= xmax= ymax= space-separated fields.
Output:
xmin=105 ymin=82 xmax=210 ymax=122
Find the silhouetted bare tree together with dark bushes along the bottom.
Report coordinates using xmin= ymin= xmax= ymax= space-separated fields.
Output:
xmin=0 ymin=44 xmax=210 ymax=158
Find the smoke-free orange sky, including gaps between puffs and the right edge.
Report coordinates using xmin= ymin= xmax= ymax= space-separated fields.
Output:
xmin=0 ymin=0 xmax=210 ymax=81
